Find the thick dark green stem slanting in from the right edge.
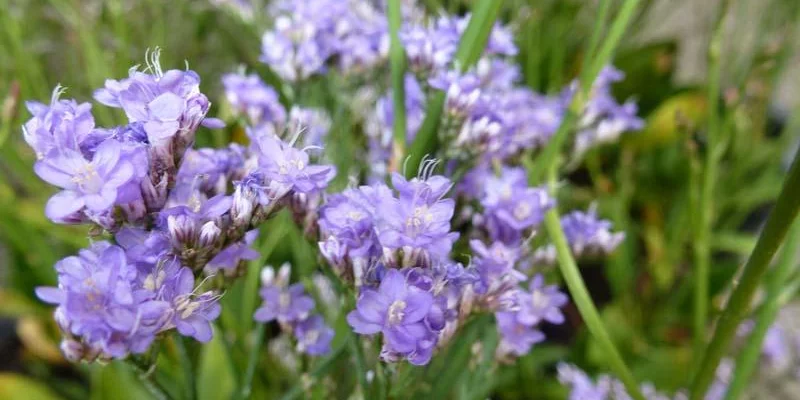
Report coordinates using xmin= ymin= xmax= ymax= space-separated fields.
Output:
xmin=690 ymin=145 xmax=800 ymax=399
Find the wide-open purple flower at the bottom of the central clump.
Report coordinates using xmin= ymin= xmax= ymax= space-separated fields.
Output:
xmin=347 ymin=269 xmax=433 ymax=354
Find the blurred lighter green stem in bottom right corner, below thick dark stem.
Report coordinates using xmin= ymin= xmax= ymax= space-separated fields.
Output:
xmin=725 ymin=221 xmax=800 ymax=400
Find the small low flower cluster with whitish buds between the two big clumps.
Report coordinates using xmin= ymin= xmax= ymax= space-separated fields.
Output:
xmin=254 ymin=264 xmax=333 ymax=355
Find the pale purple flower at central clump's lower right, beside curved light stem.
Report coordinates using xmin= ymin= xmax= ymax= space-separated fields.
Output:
xmin=516 ymin=275 xmax=567 ymax=326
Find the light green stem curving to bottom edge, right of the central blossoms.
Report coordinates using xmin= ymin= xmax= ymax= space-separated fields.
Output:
xmin=544 ymin=163 xmax=644 ymax=400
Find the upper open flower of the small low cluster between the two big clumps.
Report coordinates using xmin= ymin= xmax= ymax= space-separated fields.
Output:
xmin=254 ymin=283 xmax=314 ymax=323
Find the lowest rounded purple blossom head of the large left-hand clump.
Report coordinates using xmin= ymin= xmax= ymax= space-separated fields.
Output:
xmin=37 ymin=242 xmax=219 ymax=361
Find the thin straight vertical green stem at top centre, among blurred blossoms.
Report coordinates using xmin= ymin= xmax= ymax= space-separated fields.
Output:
xmin=388 ymin=0 xmax=406 ymax=171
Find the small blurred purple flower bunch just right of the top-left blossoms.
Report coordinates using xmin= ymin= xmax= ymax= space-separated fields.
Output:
xmin=222 ymin=74 xmax=286 ymax=125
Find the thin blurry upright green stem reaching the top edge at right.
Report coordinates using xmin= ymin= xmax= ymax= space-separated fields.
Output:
xmin=693 ymin=0 xmax=730 ymax=359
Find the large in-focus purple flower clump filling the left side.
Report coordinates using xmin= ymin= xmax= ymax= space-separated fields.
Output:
xmin=23 ymin=51 xmax=335 ymax=361
